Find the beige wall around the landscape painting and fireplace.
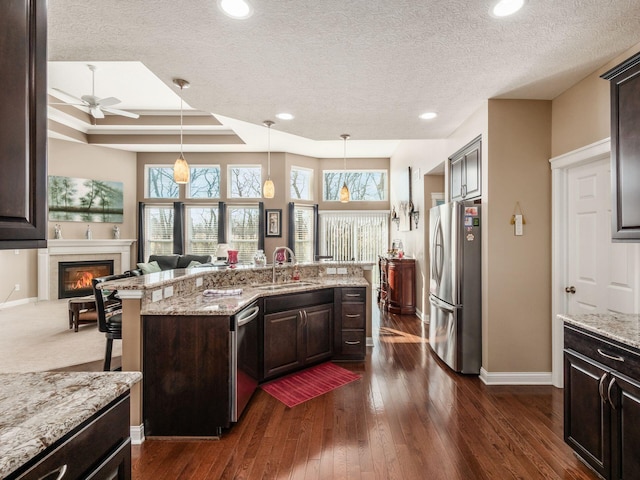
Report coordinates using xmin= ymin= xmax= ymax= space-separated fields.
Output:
xmin=0 ymin=138 xmax=137 ymax=307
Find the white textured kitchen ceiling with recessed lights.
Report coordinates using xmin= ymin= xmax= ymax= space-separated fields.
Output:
xmin=48 ymin=0 xmax=640 ymax=148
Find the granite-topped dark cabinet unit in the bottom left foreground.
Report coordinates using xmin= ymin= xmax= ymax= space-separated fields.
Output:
xmin=0 ymin=372 xmax=142 ymax=479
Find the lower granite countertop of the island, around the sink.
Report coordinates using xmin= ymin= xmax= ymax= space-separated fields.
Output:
xmin=140 ymin=277 xmax=369 ymax=315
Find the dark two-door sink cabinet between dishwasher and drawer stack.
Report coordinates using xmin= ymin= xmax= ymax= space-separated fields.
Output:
xmin=262 ymin=289 xmax=334 ymax=380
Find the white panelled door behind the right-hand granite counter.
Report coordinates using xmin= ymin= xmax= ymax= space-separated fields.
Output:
xmin=566 ymin=159 xmax=638 ymax=314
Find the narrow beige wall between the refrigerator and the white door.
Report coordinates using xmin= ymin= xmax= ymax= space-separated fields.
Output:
xmin=482 ymin=100 xmax=551 ymax=373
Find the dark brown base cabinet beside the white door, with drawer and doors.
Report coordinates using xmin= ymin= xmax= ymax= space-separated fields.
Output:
xmin=564 ymin=325 xmax=640 ymax=479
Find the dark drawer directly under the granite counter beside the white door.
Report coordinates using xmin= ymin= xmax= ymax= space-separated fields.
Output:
xmin=564 ymin=325 xmax=640 ymax=378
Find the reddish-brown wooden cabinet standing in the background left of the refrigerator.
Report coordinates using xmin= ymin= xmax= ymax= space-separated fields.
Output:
xmin=378 ymin=257 xmax=416 ymax=315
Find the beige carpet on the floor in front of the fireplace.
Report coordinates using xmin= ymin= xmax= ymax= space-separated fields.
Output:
xmin=0 ymin=299 xmax=122 ymax=373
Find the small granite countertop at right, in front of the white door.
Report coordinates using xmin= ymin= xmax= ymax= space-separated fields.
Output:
xmin=558 ymin=313 xmax=640 ymax=349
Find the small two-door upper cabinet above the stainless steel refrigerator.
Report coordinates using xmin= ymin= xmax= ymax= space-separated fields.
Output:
xmin=449 ymin=137 xmax=482 ymax=201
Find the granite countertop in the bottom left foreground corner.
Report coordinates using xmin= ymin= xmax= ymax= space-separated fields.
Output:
xmin=0 ymin=372 xmax=142 ymax=478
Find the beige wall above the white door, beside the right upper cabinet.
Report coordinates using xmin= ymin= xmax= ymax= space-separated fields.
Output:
xmin=551 ymin=44 xmax=640 ymax=157
